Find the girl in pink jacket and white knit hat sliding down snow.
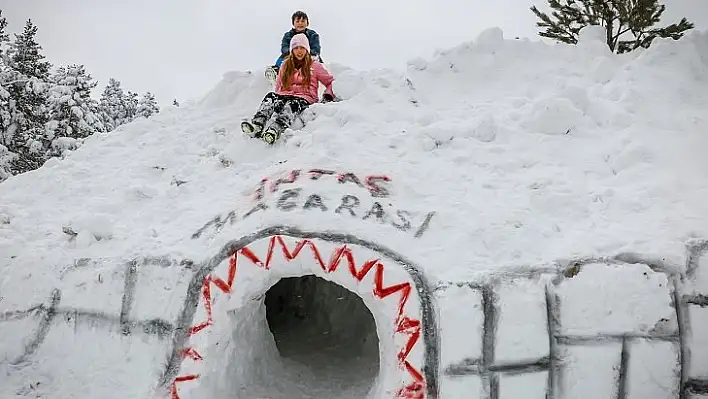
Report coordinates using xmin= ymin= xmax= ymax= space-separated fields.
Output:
xmin=241 ymin=33 xmax=334 ymax=144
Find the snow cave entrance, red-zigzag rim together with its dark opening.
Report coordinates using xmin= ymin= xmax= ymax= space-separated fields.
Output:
xmin=170 ymin=235 xmax=425 ymax=399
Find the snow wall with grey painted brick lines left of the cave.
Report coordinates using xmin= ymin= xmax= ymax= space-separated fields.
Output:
xmin=0 ymin=257 xmax=185 ymax=398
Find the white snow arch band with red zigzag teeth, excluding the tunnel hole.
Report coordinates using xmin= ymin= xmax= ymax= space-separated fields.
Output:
xmin=163 ymin=227 xmax=438 ymax=399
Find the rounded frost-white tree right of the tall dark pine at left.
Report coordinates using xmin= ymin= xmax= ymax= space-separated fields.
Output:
xmin=47 ymin=65 xmax=105 ymax=156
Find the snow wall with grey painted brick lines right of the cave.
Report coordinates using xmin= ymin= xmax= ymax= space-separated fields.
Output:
xmin=434 ymin=241 xmax=708 ymax=399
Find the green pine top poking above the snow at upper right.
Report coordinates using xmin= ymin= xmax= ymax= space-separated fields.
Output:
xmin=531 ymin=0 xmax=693 ymax=53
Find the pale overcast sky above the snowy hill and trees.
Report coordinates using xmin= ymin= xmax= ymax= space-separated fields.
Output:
xmin=0 ymin=0 xmax=708 ymax=105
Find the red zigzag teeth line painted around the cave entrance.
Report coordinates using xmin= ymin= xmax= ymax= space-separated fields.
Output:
xmin=172 ymin=235 xmax=425 ymax=399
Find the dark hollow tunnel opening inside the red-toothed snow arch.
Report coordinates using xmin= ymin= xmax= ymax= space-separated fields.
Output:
xmin=264 ymin=275 xmax=380 ymax=399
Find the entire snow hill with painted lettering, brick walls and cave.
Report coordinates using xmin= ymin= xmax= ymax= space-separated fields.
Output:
xmin=0 ymin=28 xmax=708 ymax=399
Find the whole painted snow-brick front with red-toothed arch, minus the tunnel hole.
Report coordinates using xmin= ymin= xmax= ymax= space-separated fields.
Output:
xmin=5 ymin=234 xmax=708 ymax=398
